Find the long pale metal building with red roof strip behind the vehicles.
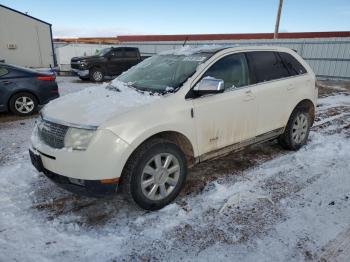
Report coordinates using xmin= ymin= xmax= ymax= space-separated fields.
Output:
xmin=55 ymin=31 xmax=350 ymax=80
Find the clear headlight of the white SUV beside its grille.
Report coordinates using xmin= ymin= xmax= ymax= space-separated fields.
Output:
xmin=64 ymin=127 xmax=95 ymax=150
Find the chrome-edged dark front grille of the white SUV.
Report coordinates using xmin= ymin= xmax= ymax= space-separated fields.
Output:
xmin=38 ymin=120 xmax=68 ymax=149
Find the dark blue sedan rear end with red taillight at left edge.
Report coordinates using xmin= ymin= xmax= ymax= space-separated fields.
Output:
xmin=0 ymin=63 xmax=59 ymax=116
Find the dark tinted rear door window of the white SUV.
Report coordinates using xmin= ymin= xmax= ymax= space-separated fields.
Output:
xmin=247 ymin=51 xmax=290 ymax=83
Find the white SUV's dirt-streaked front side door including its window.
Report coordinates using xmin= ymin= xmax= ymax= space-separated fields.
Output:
xmin=193 ymin=53 xmax=257 ymax=155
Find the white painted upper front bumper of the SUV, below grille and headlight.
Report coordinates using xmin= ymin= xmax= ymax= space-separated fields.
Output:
xmin=31 ymin=128 xmax=132 ymax=180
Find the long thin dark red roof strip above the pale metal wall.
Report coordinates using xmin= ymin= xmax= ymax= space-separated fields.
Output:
xmin=116 ymin=31 xmax=350 ymax=42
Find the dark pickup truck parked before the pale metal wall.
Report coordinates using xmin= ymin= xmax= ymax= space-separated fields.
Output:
xmin=71 ymin=47 xmax=142 ymax=82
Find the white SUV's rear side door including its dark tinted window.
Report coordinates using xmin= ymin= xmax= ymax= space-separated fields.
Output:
xmin=247 ymin=51 xmax=293 ymax=135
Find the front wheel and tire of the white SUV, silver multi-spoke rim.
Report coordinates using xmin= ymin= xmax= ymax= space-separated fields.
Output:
xmin=121 ymin=139 xmax=187 ymax=211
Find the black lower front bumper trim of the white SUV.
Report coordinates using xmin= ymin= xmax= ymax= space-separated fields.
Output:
xmin=29 ymin=149 xmax=118 ymax=197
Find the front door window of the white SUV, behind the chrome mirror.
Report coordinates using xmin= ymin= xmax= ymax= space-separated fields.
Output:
xmin=202 ymin=54 xmax=249 ymax=90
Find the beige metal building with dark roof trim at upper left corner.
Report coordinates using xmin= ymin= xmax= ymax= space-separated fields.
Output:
xmin=0 ymin=5 xmax=56 ymax=68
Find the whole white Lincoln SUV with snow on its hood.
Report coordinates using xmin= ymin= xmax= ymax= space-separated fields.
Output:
xmin=30 ymin=46 xmax=317 ymax=210
